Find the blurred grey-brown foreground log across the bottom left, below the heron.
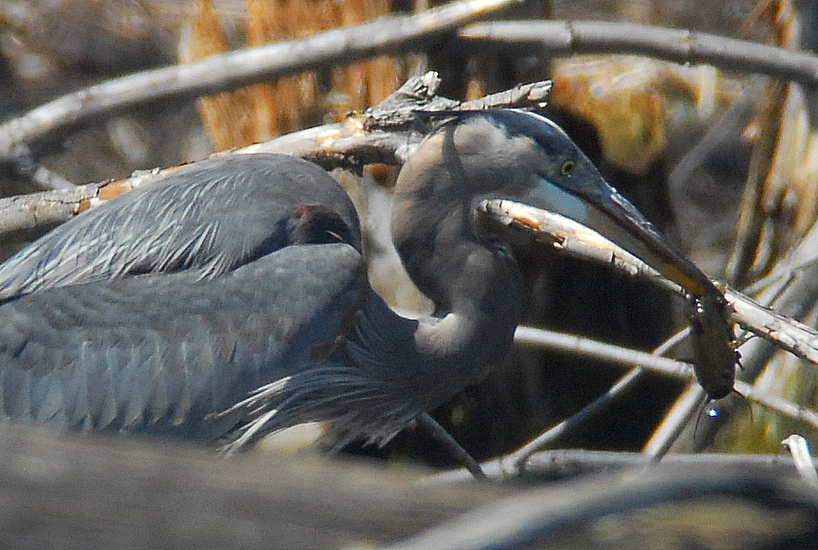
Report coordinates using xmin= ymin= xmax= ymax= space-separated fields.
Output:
xmin=0 ymin=425 xmax=509 ymax=549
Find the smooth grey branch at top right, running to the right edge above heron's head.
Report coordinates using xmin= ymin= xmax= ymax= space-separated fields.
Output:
xmin=459 ymin=21 xmax=818 ymax=86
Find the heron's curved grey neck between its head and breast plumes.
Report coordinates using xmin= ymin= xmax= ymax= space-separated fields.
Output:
xmin=378 ymin=202 xmax=522 ymax=394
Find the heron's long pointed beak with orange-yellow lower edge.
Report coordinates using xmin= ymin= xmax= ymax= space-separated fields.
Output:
xmin=524 ymin=175 xmax=721 ymax=296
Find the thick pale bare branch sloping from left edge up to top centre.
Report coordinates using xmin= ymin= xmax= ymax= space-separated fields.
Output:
xmin=0 ymin=0 xmax=516 ymax=163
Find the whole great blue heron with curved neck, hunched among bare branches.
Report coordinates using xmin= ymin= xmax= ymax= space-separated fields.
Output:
xmin=0 ymin=110 xmax=720 ymax=452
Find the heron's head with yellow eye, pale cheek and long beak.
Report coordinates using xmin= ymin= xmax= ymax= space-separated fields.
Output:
xmin=397 ymin=109 xmax=720 ymax=295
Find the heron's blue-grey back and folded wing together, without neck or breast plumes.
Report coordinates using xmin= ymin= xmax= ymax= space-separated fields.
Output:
xmin=0 ymin=155 xmax=365 ymax=439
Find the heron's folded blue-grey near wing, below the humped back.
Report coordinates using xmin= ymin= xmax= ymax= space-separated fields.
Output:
xmin=0 ymin=244 xmax=369 ymax=439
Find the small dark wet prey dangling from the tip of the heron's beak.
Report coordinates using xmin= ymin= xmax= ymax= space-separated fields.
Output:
xmin=687 ymin=294 xmax=739 ymax=399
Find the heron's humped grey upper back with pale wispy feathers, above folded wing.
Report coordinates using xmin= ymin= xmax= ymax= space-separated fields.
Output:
xmin=0 ymin=154 xmax=361 ymax=300
